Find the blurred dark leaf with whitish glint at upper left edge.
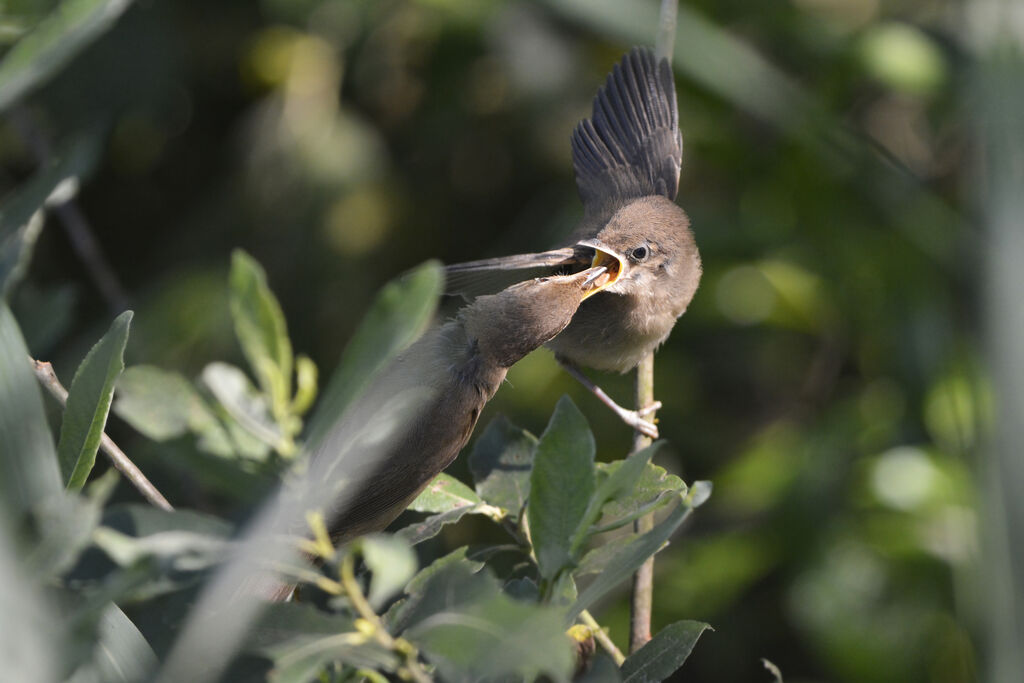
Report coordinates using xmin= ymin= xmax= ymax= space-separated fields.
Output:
xmin=0 ymin=136 xmax=99 ymax=299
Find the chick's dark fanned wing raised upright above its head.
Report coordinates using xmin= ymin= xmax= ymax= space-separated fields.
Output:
xmin=572 ymin=47 xmax=683 ymax=222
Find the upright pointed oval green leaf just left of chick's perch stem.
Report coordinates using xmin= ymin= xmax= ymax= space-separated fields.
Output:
xmin=527 ymin=396 xmax=595 ymax=579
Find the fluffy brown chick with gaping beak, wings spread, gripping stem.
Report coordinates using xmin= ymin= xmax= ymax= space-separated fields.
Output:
xmin=446 ymin=48 xmax=701 ymax=437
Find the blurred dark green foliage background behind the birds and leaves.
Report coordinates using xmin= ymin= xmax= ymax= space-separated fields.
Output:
xmin=0 ymin=0 xmax=992 ymax=682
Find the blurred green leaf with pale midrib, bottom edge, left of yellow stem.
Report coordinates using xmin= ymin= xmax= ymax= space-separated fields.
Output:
xmin=246 ymin=603 xmax=398 ymax=683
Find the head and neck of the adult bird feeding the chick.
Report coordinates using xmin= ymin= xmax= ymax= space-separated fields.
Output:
xmin=460 ymin=266 xmax=616 ymax=368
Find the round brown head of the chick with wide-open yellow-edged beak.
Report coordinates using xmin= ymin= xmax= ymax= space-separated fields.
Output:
xmin=580 ymin=196 xmax=701 ymax=318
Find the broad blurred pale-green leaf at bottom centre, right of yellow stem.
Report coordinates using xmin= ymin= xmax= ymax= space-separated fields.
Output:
xmin=404 ymin=564 xmax=573 ymax=681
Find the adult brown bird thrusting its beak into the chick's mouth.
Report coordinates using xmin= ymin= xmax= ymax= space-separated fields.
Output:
xmin=313 ymin=268 xmax=609 ymax=541
